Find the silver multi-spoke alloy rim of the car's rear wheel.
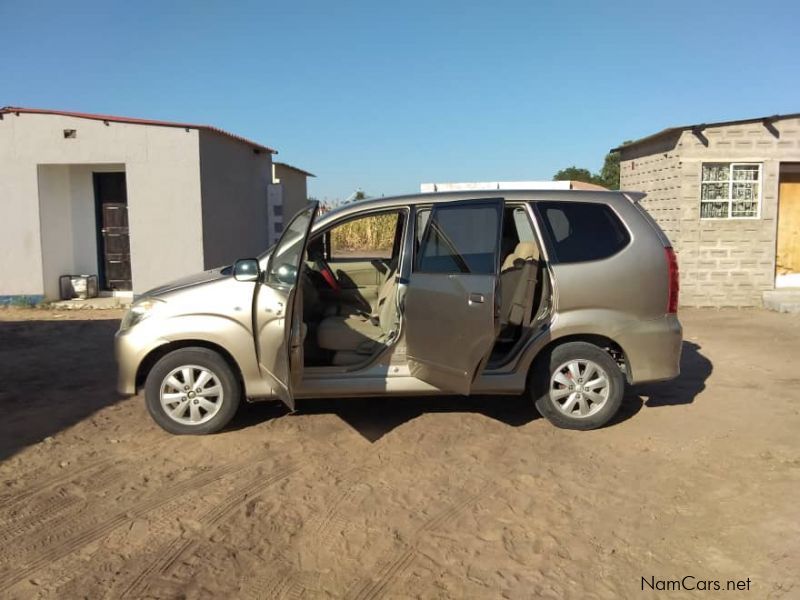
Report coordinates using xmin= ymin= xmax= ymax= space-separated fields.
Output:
xmin=550 ymin=359 xmax=611 ymax=419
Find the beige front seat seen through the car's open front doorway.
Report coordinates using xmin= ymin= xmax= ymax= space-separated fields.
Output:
xmin=317 ymin=273 xmax=398 ymax=365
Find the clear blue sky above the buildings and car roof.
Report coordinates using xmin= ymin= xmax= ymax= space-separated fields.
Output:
xmin=0 ymin=0 xmax=800 ymax=200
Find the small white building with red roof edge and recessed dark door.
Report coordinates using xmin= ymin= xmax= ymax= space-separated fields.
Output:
xmin=0 ymin=107 xmax=275 ymax=303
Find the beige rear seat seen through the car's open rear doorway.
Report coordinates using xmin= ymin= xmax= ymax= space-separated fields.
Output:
xmin=500 ymin=242 xmax=539 ymax=338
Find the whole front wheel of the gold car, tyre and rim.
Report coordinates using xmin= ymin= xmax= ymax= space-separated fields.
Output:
xmin=145 ymin=348 xmax=242 ymax=435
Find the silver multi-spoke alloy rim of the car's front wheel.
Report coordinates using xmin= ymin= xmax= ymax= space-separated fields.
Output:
xmin=160 ymin=365 xmax=224 ymax=425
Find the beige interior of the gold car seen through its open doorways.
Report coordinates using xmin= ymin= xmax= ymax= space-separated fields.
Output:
xmin=301 ymin=205 xmax=549 ymax=369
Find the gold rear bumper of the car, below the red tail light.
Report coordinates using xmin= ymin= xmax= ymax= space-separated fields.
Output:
xmin=617 ymin=315 xmax=683 ymax=383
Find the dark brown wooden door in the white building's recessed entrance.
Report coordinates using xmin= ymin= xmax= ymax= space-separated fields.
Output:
xmin=94 ymin=173 xmax=131 ymax=290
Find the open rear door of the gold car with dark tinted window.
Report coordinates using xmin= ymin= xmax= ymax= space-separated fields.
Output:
xmin=404 ymin=199 xmax=503 ymax=394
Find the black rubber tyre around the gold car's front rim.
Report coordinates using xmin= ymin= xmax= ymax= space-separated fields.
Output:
xmin=144 ymin=348 xmax=242 ymax=435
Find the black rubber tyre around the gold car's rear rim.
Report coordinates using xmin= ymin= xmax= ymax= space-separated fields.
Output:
xmin=530 ymin=342 xmax=625 ymax=430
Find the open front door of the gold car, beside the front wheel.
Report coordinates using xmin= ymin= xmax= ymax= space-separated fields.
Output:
xmin=253 ymin=202 xmax=319 ymax=410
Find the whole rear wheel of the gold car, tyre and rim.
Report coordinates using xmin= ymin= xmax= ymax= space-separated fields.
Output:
xmin=531 ymin=342 xmax=625 ymax=430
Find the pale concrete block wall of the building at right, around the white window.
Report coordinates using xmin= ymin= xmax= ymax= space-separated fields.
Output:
xmin=620 ymin=119 xmax=800 ymax=307
